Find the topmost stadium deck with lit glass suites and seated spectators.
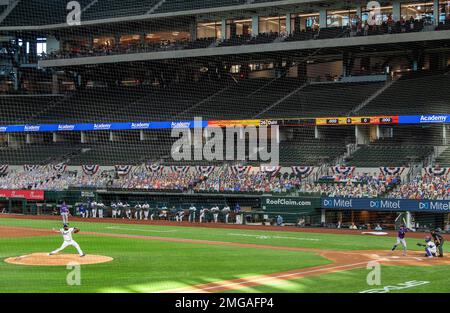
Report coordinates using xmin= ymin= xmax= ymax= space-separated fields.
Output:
xmin=0 ymin=0 xmax=450 ymax=67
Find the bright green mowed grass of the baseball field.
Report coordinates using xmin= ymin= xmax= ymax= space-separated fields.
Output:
xmin=0 ymin=218 xmax=450 ymax=292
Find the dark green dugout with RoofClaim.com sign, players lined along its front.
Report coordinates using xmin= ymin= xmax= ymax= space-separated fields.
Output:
xmin=29 ymin=189 xmax=321 ymax=226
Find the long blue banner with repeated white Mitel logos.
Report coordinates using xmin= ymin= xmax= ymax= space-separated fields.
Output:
xmin=322 ymin=198 xmax=450 ymax=213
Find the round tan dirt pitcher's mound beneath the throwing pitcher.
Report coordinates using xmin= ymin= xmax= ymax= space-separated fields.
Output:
xmin=5 ymin=253 xmax=113 ymax=266
